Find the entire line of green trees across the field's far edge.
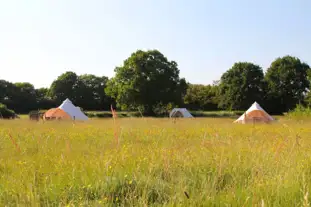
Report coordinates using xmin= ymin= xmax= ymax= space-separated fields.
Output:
xmin=0 ymin=50 xmax=311 ymax=115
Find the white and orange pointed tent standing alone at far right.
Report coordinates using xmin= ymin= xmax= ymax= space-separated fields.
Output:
xmin=234 ymin=102 xmax=274 ymax=124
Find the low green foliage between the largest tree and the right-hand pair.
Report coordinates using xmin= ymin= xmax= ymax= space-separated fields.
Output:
xmin=184 ymin=84 xmax=218 ymax=111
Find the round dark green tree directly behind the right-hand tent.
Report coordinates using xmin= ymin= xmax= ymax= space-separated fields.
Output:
xmin=219 ymin=62 xmax=265 ymax=110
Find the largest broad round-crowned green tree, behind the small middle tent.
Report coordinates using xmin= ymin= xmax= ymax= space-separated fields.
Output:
xmin=106 ymin=50 xmax=187 ymax=114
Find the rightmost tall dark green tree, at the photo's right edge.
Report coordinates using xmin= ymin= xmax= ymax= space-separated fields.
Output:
xmin=265 ymin=56 xmax=310 ymax=113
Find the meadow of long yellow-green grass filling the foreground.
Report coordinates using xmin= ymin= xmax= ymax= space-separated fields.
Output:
xmin=0 ymin=118 xmax=311 ymax=206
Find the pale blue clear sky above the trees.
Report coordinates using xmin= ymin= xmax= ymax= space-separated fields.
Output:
xmin=0 ymin=0 xmax=311 ymax=88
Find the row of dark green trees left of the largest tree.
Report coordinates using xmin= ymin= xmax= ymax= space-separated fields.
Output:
xmin=0 ymin=72 xmax=112 ymax=113
